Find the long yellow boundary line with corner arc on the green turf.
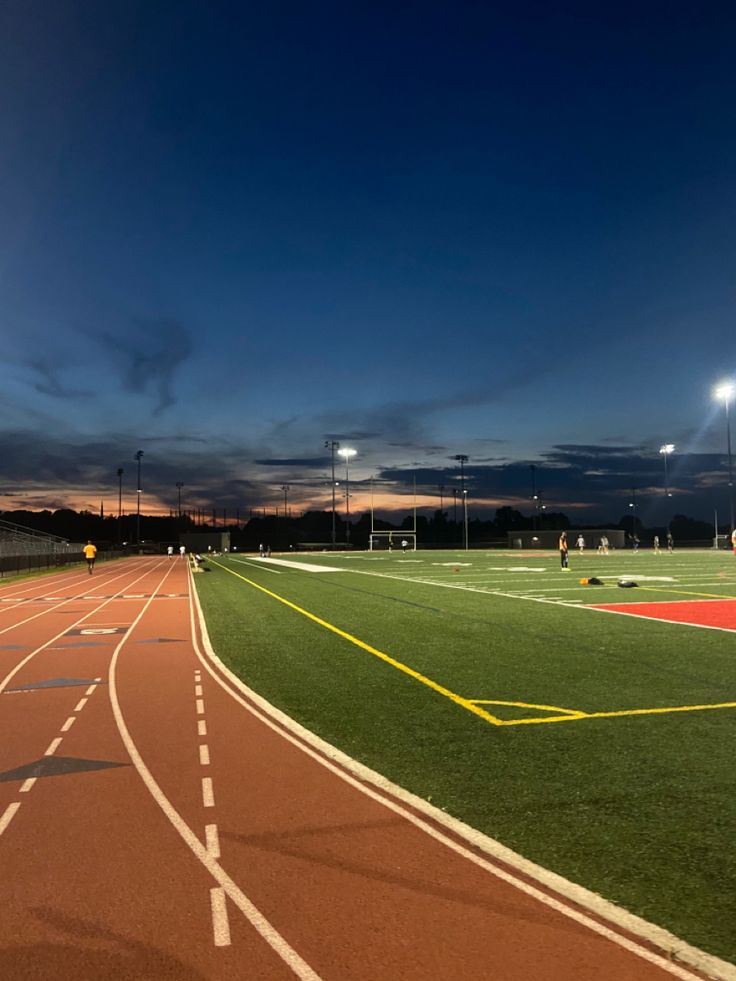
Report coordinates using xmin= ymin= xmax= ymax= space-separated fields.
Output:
xmin=212 ymin=560 xmax=736 ymax=726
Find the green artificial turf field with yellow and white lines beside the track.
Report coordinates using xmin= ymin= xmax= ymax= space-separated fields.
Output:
xmin=195 ymin=551 xmax=736 ymax=960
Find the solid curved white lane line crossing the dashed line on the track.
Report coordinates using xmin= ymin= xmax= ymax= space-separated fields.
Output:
xmin=108 ymin=570 xmax=322 ymax=981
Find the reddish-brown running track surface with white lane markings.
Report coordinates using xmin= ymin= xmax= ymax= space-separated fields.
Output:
xmin=0 ymin=558 xmax=720 ymax=981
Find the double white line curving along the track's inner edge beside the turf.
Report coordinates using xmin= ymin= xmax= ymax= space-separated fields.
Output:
xmin=190 ymin=573 xmax=736 ymax=981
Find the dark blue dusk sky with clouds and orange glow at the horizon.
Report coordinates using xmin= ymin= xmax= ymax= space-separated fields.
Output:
xmin=0 ymin=0 xmax=736 ymax=523
